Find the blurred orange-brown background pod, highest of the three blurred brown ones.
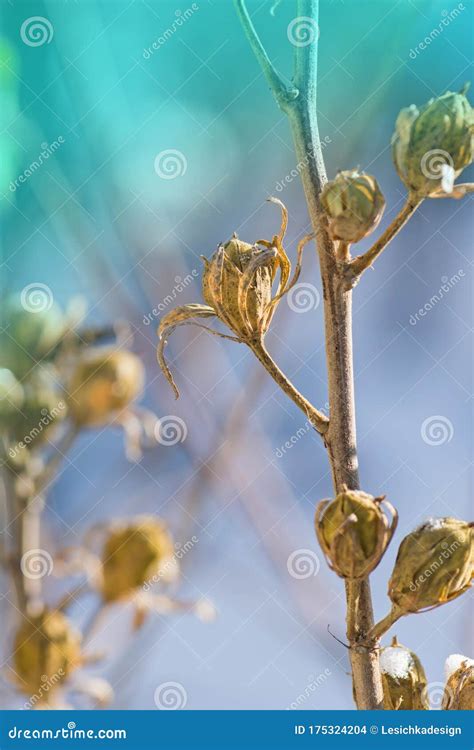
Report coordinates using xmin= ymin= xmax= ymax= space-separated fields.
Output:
xmin=68 ymin=347 xmax=145 ymax=426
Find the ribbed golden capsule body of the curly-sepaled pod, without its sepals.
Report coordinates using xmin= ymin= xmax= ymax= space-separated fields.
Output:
xmin=202 ymin=237 xmax=276 ymax=339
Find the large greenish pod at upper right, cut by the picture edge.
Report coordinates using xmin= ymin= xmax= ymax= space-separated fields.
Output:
xmin=392 ymin=91 xmax=474 ymax=197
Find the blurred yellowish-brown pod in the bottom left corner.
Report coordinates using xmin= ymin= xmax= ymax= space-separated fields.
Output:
xmin=13 ymin=610 xmax=81 ymax=695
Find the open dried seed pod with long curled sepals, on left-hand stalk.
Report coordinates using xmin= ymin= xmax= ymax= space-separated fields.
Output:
xmin=158 ymin=198 xmax=313 ymax=398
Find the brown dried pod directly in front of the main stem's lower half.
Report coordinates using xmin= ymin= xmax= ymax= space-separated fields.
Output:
xmin=315 ymin=490 xmax=397 ymax=578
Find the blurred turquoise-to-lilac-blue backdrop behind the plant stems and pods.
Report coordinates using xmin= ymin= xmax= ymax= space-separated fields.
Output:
xmin=0 ymin=0 xmax=473 ymax=709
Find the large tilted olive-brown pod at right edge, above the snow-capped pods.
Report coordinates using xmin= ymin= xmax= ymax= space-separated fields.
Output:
xmin=388 ymin=518 xmax=474 ymax=613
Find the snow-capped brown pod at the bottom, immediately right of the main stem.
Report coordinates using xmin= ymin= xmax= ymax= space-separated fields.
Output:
xmin=380 ymin=637 xmax=429 ymax=711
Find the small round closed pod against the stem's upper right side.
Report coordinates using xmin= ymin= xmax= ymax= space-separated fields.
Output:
xmin=321 ymin=170 xmax=385 ymax=242
